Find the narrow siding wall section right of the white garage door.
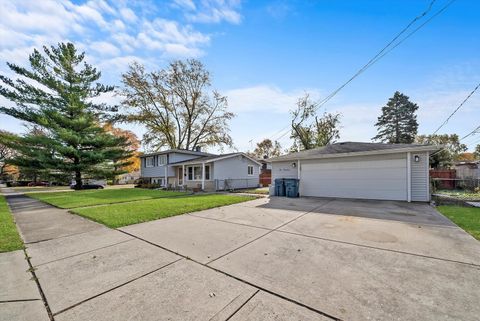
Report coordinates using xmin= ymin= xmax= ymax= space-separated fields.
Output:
xmin=410 ymin=152 xmax=430 ymax=202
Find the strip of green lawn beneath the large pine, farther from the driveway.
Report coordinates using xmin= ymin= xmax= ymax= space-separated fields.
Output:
xmin=27 ymin=188 xmax=185 ymax=208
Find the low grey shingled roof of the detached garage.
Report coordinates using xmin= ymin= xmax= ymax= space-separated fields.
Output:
xmin=267 ymin=142 xmax=442 ymax=162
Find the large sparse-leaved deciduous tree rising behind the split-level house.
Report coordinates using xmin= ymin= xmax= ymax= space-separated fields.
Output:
xmin=120 ymin=59 xmax=235 ymax=150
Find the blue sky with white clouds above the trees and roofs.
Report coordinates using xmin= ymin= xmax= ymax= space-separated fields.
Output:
xmin=0 ymin=0 xmax=480 ymax=151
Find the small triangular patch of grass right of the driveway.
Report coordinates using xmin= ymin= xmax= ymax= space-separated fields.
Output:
xmin=437 ymin=205 xmax=480 ymax=240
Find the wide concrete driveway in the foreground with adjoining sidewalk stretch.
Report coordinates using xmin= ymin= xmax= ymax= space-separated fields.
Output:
xmin=0 ymin=194 xmax=480 ymax=321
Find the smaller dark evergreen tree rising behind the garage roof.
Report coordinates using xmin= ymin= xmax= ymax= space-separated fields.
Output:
xmin=372 ymin=91 xmax=418 ymax=144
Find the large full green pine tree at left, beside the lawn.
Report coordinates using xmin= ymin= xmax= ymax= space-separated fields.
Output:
xmin=0 ymin=43 xmax=130 ymax=189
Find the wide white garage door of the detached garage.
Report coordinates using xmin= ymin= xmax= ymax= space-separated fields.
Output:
xmin=300 ymin=154 xmax=407 ymax=200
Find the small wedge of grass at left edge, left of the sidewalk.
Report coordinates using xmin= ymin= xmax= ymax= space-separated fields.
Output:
xmin=0 ymin=195 xmax=23 ymax=252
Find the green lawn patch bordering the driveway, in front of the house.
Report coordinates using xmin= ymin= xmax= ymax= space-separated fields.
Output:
xmin=72 ymin=194 xmax=255 ymax=228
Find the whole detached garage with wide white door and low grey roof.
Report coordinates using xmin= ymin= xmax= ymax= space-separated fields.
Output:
xmin=269 ymin=142 xmax=440 ymax=202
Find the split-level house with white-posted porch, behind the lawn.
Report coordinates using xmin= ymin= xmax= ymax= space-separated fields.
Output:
xmin=140 ymin=149 xmax=261 ymax=191
